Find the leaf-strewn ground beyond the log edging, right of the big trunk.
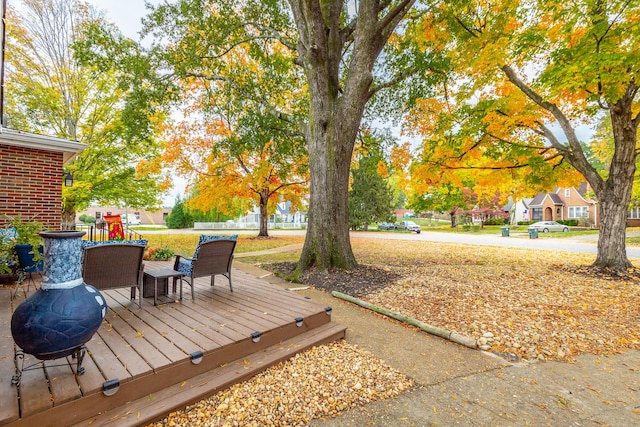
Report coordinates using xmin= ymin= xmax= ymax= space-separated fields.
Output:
xmin=273 ymin=238 xmax=640 ymax=361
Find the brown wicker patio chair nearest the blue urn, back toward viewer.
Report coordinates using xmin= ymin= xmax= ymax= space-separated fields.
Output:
xmin=82 ymin=243 xmax=145 ymax=307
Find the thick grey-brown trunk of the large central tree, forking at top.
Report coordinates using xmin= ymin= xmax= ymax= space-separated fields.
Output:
xmin=289 ymin=0 xmax=415 ymax=271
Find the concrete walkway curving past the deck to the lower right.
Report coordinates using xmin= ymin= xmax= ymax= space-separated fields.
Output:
xmin=234 ymin=244 xmax=640 ymax=427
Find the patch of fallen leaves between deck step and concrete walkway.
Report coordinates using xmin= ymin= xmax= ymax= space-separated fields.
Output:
xmin=151 ymin=341 xmax=413 ymax=427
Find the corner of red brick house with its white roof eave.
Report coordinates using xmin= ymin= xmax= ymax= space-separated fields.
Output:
xmin=0 ymin=126 xmax=85 ymax=230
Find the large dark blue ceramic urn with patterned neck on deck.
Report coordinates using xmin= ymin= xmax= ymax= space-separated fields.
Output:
xmin=11 ymin=231 xmax=107 ymax=360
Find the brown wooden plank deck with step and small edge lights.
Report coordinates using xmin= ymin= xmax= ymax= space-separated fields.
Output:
xmin=0 ymin=262 xmax=345 ymax=427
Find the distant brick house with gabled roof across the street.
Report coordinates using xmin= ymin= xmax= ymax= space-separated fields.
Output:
xmin=529 ymin=183 xmax=600 ymax=228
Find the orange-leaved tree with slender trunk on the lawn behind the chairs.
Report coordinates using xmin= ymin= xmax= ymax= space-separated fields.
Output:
xmin=165 ymin=121 xmax=307 ymax=237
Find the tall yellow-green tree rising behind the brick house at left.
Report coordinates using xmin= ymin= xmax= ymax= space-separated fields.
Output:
xmin=5 ymin=0 xmax=161 ymax=222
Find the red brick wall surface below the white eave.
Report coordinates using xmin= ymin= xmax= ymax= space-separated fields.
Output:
xmin=0 ymin=145 xmax=63 ymax=230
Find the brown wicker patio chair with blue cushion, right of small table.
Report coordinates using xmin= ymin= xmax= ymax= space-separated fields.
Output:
xmin=173 ymin=236 xmax=237 ymax=299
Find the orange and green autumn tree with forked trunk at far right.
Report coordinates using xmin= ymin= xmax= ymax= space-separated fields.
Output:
xmin=408 ymin=0 xmax=640 ymax=270
